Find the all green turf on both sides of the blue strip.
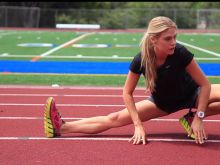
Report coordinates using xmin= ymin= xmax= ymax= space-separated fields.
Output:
xmin=0 ymin=30 xmax=220 ymax=86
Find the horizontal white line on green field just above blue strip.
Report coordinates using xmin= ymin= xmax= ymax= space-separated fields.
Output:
xmin=0 ymin=54 xmax=220 ymax=61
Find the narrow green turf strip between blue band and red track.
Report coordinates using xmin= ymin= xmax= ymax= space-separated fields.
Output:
xmin=0 ymin=73 xmax=220 ymax=86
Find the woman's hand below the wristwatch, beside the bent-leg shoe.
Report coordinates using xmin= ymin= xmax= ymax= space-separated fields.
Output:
xmin=189 ymin=116 xmax=207 ymax=144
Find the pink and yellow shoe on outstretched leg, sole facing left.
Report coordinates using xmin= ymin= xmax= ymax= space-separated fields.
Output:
xmin=44 ymin=97 xmax=64 ymax=138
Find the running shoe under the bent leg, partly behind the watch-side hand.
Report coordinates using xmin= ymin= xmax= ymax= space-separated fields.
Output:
xmin=179 ymin=111 xmax=195 ymax=139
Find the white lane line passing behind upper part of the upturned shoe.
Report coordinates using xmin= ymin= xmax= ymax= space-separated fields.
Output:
xmin=0 ymin=103 xmax=125 ymax=107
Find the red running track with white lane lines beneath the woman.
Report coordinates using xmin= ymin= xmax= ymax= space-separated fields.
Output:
xmin=0 ymin=86 xmax=220 ymax=165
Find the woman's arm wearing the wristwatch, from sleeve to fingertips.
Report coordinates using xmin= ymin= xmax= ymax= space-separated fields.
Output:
xmin=186 ymin=59 xmax=211 ymax=143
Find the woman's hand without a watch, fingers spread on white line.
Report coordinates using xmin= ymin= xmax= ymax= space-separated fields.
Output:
xmin=129 ymin=124 xmax=146 ymax=145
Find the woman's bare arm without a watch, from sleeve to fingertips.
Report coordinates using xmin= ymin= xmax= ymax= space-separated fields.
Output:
xmin=123 ymin=71 xmax=145 ymax=144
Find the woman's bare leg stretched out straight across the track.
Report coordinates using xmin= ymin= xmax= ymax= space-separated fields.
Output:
xmin=61 ymin=100 xmax=167 ymax=134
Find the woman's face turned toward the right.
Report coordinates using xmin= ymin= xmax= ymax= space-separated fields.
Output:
xmin=152 ymin=28 xmax=177 ymax=57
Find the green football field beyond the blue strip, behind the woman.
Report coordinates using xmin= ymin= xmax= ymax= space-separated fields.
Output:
xmin=0 ymin=31 xmax=220 ymax=62
